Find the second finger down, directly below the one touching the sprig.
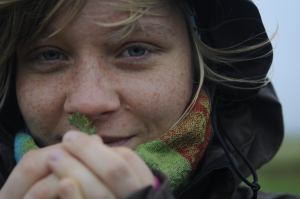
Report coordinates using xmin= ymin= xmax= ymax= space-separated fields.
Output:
xmin=48 ymin=151 xmax=115 ymax=199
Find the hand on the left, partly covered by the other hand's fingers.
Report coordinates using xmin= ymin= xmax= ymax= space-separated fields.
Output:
xmin=0 ymin=144 xmax=64 ymax=199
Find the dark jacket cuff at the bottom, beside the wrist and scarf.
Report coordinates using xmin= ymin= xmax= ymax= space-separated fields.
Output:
xmin=124 ymin=169 xmax=175 ymax=199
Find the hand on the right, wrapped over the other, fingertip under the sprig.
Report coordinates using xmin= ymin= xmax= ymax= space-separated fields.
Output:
xmin=47 ymin=131 xmax=154 ymax=199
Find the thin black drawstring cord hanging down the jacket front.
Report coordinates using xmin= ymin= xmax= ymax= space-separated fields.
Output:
xmin=211 ymin=98 xmax=260 ymax=199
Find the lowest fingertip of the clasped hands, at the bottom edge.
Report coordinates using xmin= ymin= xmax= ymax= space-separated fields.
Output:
xmin=58 ymin=178 xmax=84 ymax=199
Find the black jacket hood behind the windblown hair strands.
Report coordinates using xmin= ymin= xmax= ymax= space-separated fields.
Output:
xmin=187 ymin=0 xmax=273 ymax=100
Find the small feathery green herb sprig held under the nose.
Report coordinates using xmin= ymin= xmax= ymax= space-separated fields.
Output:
xmin=68 ymin=113 xmax=97 ymax=135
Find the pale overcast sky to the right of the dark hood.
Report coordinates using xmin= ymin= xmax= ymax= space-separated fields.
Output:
xmin=253 ymin=0 xmax=300 ymax=137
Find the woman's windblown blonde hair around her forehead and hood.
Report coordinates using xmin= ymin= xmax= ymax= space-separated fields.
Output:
xmin=0 ymin=0 xmax=272 ymax=126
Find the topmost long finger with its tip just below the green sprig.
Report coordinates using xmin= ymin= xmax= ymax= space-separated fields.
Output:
xmin=63 ymin=132 xmax=144 ymax=198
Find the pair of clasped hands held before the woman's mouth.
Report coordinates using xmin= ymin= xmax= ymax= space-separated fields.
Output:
xmin=0 ymin=133 xmax=154 ymax=199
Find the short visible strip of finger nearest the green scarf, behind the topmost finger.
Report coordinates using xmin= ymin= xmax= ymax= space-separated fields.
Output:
xmin=111 ymin=147 xmax=155 ymax=187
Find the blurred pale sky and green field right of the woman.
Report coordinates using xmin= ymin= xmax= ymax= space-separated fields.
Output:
xmin=249 ymin=0 xmax=300 ymax=195
